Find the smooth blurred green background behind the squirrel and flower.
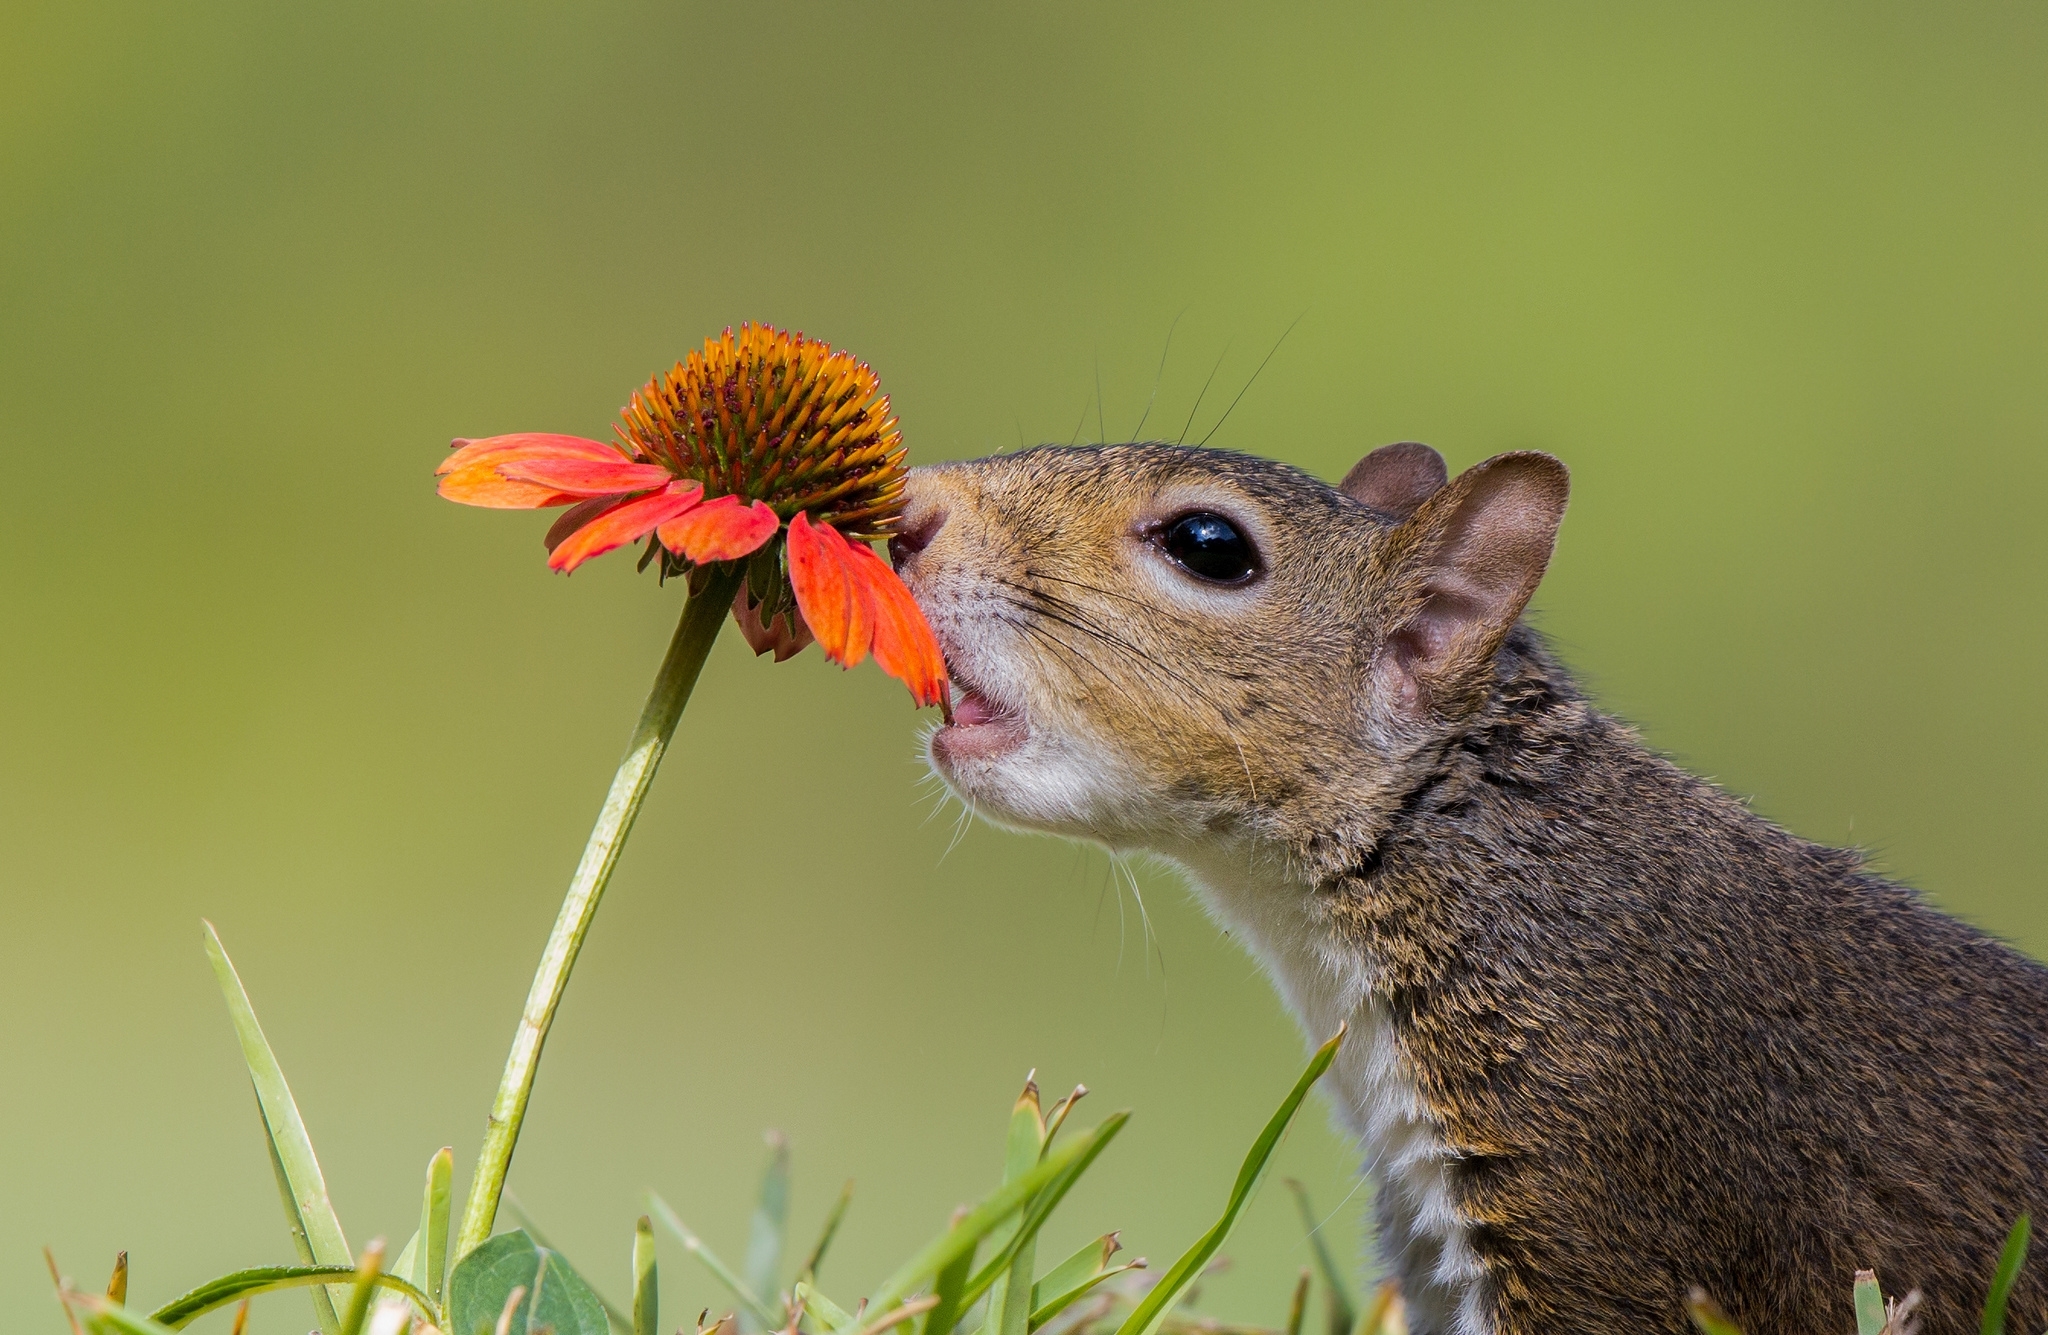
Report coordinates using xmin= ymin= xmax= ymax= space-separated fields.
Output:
xmin=0 ymin=0 xmax=2048 ymax=1335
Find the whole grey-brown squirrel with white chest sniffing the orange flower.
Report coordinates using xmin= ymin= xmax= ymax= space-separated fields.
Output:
xmin=891 ymin=442 xmax=2048 ymax=1335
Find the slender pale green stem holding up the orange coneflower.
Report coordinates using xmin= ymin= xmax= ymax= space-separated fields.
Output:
xmin=453 ymin=567 xmax=741 ymax=1261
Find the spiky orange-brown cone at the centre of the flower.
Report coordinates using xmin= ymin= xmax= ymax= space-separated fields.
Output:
xmin=618 ymin=324 xmax=905 ymax=541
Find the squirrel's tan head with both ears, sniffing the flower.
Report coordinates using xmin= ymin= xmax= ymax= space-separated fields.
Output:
xmin=891 ymin=444 xmax=1567 ymax=876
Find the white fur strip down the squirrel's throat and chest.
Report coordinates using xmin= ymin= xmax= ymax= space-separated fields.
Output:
xmin=1174 ymin=850 xmax=1493 ymax=1335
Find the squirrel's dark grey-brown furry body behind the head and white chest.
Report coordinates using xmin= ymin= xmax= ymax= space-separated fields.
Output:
xmin=1333 ymin=629 xmax=2048 ymax=1333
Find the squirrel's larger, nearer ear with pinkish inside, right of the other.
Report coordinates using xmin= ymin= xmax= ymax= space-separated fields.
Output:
xmin=1376 ymin=453 xmax=1571 ymax=713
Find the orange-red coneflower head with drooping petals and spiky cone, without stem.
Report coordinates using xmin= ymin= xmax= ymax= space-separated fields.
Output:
xmin=436 ymin=326 xmax=946 ymax=704
